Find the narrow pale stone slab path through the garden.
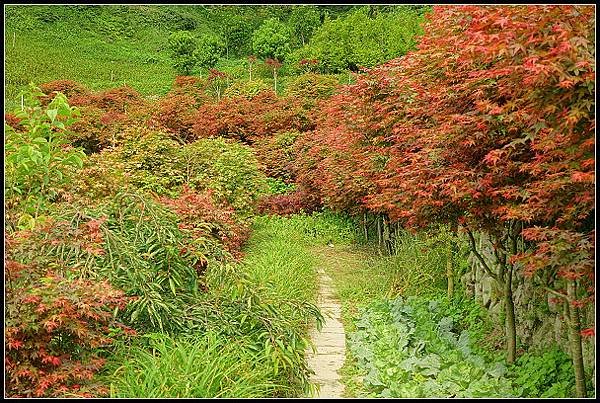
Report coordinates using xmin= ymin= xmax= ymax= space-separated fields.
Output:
xmin=307 ymin=269 xmax=346 ymax=398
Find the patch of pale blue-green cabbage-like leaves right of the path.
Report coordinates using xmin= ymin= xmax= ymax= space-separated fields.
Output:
xmin=349 ymin=298 xmax=514 ymax=398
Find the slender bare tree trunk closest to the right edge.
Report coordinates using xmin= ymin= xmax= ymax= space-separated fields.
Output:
xmin=567 ymin=280 xmax=587 ymax=397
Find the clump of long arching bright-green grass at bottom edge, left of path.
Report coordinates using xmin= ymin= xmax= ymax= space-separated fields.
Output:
xmin=106 ymin=333 xmax=282 ymax=398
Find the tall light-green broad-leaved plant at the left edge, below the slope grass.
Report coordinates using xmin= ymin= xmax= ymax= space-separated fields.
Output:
xmin=4 ymin=84 xmax=85 ymax=232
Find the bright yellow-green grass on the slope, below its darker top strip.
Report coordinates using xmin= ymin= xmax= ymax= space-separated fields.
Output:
xmin=4 ymin=22 xmax=176 ymax=110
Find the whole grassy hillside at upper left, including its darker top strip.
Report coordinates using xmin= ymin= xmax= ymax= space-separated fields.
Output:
xmin=4 ymin=5 xmax=209 ymax=110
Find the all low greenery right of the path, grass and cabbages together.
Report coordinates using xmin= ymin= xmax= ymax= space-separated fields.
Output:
xmin=330 ymin=229 xmax=592 ymax=398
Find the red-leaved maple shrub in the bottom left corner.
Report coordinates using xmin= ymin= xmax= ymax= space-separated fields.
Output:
xmin=4 ymin=230 xmax=133 ymax=397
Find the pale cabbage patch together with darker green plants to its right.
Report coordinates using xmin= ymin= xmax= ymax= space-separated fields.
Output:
xmin=349 ymin=297 xmax=574 ymax=398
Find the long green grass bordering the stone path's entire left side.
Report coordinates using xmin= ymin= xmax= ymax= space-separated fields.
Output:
xmin=106 ymin=216 xmax=356 ymax=397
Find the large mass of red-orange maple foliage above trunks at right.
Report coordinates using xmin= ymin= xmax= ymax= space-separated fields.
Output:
xmin=297 ymin=5 xmax=595 ymax=318
